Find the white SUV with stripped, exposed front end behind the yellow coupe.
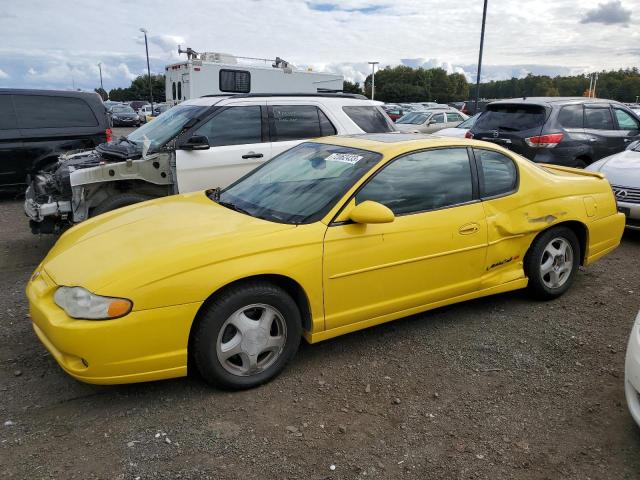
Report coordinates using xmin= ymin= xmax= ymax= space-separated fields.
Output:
xmin=24 ymin=94 xmax=395 ymax=233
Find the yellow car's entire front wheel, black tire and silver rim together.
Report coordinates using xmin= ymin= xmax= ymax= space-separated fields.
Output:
xmin=190 ymin=282 xmax=302 ymax=390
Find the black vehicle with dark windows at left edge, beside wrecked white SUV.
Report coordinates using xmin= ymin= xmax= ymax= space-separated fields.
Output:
xmin=0 ymin=88 xmax=111 ymax=189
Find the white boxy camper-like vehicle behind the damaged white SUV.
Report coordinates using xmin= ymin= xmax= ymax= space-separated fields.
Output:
xmin=165 ymin=47 xmax=344 ymax=105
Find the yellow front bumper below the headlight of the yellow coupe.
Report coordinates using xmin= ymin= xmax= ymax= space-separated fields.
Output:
xmin=27 ymin=267 xmax=201 ymax=384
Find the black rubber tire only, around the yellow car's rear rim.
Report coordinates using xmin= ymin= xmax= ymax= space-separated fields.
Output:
xmin=524 ymin=226 xmax=581 ymax=300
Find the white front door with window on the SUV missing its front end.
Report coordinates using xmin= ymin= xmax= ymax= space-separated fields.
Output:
xmin=176 ymin=101 xmax=271 ymax=193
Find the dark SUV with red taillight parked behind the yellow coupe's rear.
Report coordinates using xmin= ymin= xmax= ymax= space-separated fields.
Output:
xmin=467 ymin=97 xmax=640 ymax=168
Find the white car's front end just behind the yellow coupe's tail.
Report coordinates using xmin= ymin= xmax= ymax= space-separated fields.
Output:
xmin=586 ymin=140 xmax=640 ymax=230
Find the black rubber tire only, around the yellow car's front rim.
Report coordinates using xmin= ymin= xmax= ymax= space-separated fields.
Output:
xmin=190 ymin=281 xmax=302 ymax=390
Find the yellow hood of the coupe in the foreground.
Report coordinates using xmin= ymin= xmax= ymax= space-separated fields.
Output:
xmin=42 ymin=192 xmax=296 ymax=296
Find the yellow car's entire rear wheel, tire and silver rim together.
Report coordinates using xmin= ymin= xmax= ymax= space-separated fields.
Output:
xmin=525 ymin=227 xmax=580 ymax=299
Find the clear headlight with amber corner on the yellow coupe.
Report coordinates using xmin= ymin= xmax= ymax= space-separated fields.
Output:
xmin=53 ymin=287 xmax=133 ymax=320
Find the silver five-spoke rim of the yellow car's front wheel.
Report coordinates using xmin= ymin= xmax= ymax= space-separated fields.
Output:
xmin=216 ymin=303 xmax=287 ymax=377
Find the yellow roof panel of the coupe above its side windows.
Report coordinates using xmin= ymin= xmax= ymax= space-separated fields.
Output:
xmin=313 ymin=133 xmax=499 ymax=154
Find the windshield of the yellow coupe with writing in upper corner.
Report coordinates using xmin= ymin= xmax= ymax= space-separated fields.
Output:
xmin=218 ymin=143 xmax=382 ymax=224
